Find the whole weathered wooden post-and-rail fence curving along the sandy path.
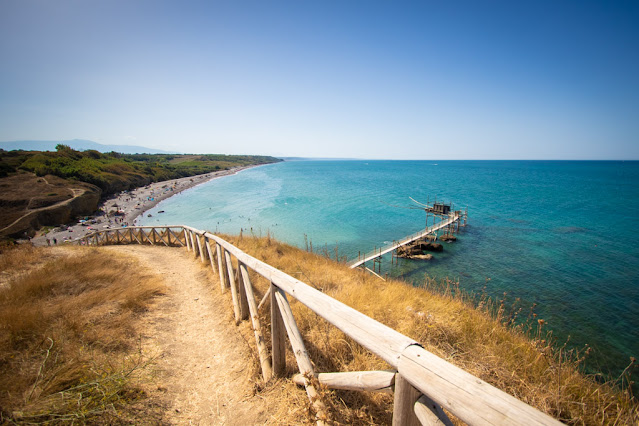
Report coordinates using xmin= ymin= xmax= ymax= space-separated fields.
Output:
xmin=77 ymin=225 xmax=560 ymax=425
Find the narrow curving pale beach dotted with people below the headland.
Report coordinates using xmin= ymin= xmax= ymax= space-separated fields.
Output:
xmin=31 ymin=166 xmax=255 ymax=246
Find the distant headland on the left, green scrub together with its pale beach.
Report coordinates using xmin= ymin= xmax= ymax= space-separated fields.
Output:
xmin=0 ymin=144 xmax=282 ymax=243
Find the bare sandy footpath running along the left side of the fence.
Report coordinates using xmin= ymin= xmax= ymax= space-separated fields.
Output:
xmin=105 ymin=246 xmax=269 ymax=425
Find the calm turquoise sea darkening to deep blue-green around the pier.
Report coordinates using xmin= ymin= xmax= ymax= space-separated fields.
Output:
xmin=142 ymin=161 xmax=639 ymax=374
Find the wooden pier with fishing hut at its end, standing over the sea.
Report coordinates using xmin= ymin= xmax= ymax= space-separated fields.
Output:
xmin=348 ymin=203 xmax=468 ymax=269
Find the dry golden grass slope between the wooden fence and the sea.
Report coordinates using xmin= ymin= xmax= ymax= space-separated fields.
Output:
xmin=223 ymin=236 xmax=639 ymax=425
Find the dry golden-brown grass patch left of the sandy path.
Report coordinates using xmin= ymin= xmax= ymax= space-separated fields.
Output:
xmin=0 ymin=246 xmax=163 ymax=423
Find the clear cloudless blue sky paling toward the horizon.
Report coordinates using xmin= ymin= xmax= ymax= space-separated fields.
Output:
xmin=0 ymin=0 xmax=639 ymax=160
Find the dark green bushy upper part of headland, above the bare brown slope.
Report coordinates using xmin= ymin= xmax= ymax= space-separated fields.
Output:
xmin=0 ymin=145 xmax=280 ymax=194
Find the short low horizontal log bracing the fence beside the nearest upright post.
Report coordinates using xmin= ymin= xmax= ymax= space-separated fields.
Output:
xmin=293 ymin=370 xmax=396 ymax=393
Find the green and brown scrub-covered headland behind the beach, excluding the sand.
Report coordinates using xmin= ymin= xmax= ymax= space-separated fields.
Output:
xmin=0 ymin=144 xmax=281 ymax=237
